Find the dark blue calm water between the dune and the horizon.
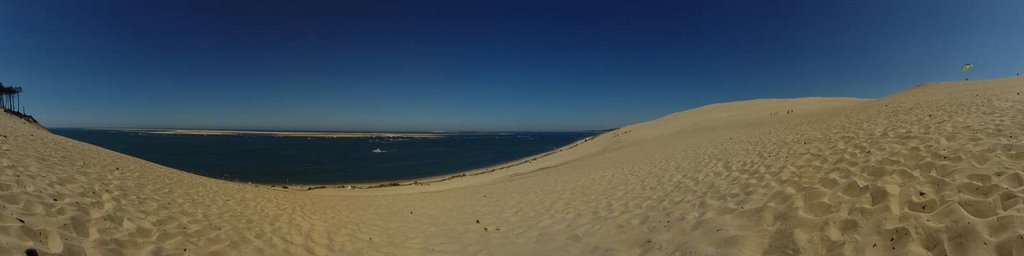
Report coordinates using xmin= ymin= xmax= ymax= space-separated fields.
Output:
xmin=51 ymin=129 xmax=595 ymax=184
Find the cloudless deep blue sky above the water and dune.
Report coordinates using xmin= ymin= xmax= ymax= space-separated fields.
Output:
xmin=0 ymin=0 xmax=1024 ymax=131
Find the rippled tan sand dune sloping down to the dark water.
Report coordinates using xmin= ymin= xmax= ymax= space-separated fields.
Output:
xmin=0 ymin=78 xmax=1024 ymax=255
